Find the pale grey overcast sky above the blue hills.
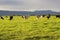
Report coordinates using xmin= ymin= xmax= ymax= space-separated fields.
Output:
xmin=0 ymin=0 xmax=60 ymax=11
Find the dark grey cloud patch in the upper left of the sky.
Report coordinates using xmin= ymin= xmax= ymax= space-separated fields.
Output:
xmin=0 ymin=0 xmax=23 ymax=6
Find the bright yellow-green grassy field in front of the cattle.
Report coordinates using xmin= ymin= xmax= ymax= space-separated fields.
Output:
xmin=0 ymin=16 xmax=60 ymax=40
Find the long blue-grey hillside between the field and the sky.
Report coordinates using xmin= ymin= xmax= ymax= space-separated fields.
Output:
xmin=0 ymin=10 xmax=60 ymax=16
